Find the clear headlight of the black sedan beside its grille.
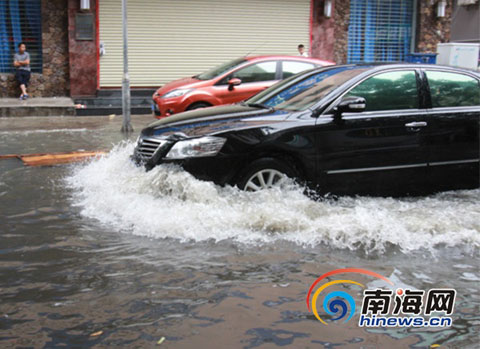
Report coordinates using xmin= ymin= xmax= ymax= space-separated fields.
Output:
xmin=165 ymin=136 xmax=227 ymax=160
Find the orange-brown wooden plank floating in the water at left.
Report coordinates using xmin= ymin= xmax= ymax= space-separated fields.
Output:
xmin=0 ymin=151 xmax=106 ymax=166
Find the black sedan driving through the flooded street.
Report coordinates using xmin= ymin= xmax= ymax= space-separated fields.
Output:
xmin=134 ymin=64 xmax=480 ymax=195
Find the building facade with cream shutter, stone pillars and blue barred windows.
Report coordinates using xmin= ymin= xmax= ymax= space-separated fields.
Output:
xmin=0 ymin=0 xmax=474 ymax=97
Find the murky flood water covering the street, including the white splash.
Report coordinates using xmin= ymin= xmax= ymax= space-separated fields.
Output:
xmin=0 ymin=116 xmax=480 ymax=349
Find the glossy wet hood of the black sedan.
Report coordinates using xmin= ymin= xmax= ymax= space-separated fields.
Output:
xmin=142 ymin=104 xmax=292 ymax=137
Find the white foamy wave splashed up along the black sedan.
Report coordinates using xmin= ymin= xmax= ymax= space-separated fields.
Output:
xmin=67 ymin=143 xmax=480 ymax=252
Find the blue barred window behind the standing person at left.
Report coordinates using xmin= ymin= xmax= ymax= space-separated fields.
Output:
xmin=0 ymin=0 xmax=42 ymax=73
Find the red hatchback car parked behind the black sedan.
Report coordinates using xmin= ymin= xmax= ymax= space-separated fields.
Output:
xmin=152 ymin=56 xmax=335 ymax=119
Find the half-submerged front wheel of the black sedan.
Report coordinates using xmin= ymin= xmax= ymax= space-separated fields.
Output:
xmin=236 ymin=158 xmax=298 ymax=191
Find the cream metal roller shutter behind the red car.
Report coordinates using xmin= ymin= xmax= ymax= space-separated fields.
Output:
xmin=99 ymin=0 xmax=310 ymax=87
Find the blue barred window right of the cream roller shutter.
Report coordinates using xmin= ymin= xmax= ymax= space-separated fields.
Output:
xmin=348 ymin=0 xmax=414 ymax=63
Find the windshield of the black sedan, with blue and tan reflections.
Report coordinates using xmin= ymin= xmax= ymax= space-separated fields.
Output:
xmin=246 ymin=66 xmax=369 ymax=111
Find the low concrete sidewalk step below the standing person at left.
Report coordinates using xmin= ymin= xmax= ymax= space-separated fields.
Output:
xmin=0 ymin=97 xmax=75 ymax=117
